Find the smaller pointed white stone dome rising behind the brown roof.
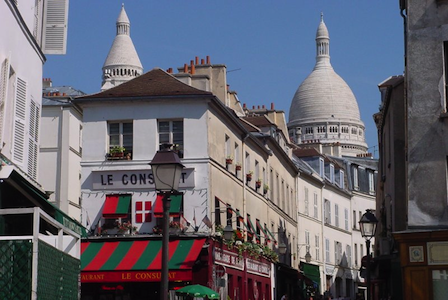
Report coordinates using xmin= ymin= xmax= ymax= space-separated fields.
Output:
xmin=101 ymin=5 xmax=143 ymax=91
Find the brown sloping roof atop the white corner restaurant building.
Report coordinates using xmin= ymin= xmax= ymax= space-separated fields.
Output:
xmin=76 ymin=68 xmax=213 ymax=101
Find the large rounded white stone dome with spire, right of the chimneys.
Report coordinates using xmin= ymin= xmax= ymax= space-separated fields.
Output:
xmin=288 ymin=17 xmax=367 ymax=156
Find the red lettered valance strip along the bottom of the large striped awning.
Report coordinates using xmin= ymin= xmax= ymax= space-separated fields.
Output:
xmin=81 ymin=270 xmax=193 ymax=283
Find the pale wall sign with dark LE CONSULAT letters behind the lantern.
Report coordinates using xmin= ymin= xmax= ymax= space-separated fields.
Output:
xmin=92 ymin=168 xmax=194 ymax=190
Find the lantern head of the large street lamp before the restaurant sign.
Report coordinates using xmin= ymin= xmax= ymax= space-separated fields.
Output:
xmin=150 ymin=150 xmax=184 ymax=192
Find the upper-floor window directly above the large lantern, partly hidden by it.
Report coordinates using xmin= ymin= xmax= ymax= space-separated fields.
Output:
xmin=158 ymin=120 xmax=184 ymax=158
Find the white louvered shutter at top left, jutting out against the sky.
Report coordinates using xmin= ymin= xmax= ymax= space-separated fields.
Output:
xmin=42 ymin=0 xmax=69 ymax=54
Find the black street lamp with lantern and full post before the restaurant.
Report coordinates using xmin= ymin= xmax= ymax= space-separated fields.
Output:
xmin=149 ymin=145 xmax=184 ymax=300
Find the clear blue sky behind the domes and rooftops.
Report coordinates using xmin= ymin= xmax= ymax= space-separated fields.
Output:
xmin=44 ymin=0 xmax=404 ymax=156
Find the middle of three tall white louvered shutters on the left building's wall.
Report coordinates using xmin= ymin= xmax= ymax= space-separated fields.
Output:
xmin=12 ymin=78 xmax=27 ymax=164
